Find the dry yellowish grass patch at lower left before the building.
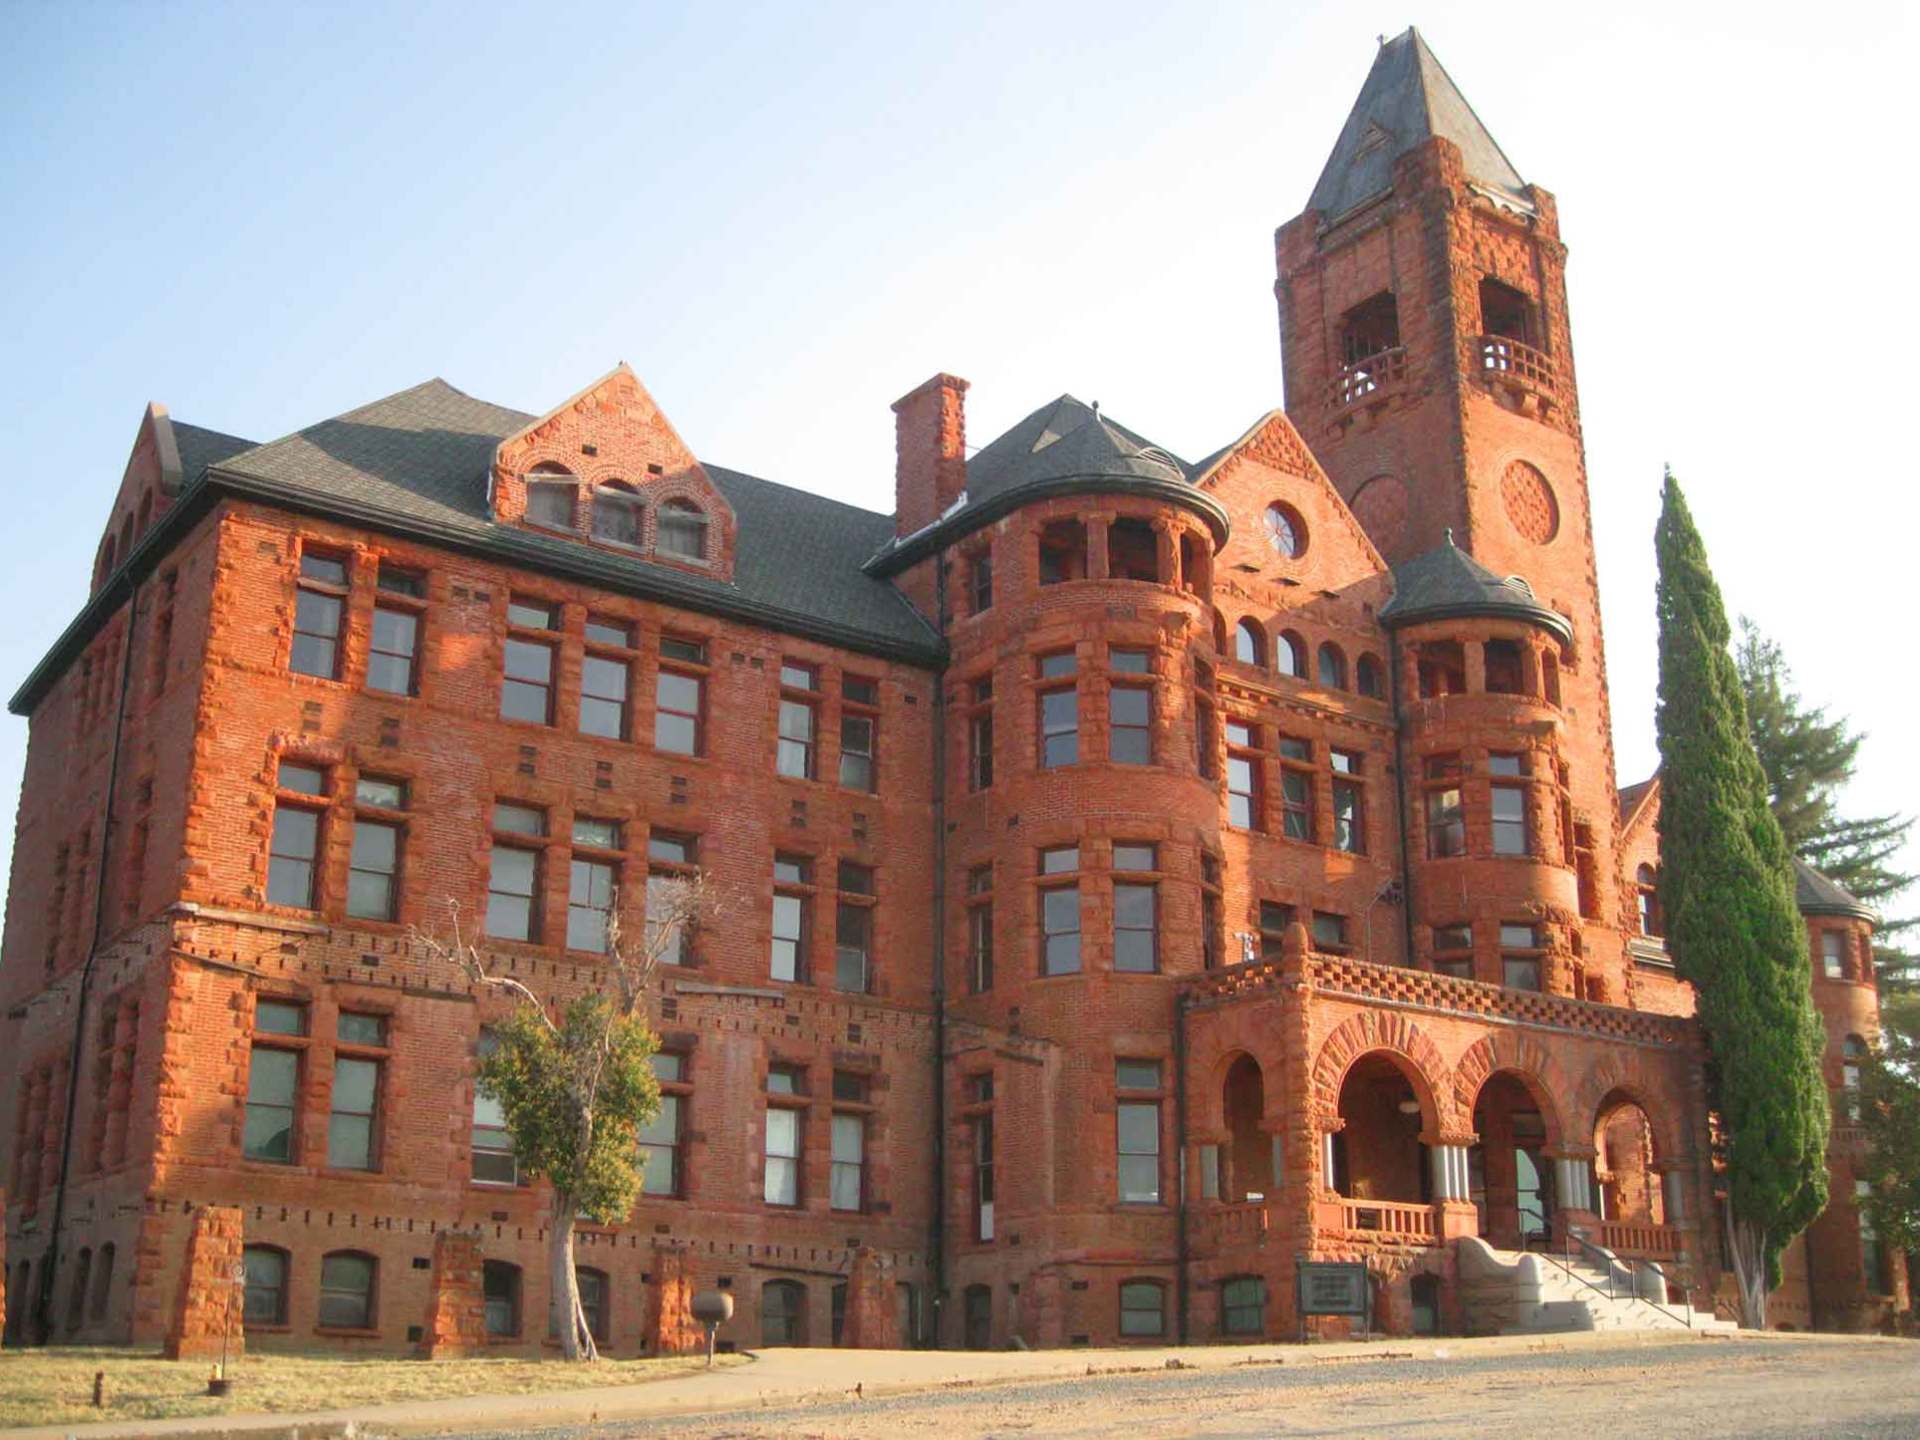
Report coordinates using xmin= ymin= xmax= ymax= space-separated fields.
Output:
xmin=0 ymin=1346 xmax=741 ymax=1427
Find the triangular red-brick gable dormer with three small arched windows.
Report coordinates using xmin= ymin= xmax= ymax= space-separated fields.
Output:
xmin=492 ymin=361 xmax=735 ymax=580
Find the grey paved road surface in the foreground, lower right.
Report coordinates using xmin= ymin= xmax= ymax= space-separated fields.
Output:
xmin=480 ymin=1338 xmax=1920 ymax=1440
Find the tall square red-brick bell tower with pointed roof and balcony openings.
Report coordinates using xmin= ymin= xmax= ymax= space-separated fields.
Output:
xmin=1275 ymin=29 xmax=1630 ymax=998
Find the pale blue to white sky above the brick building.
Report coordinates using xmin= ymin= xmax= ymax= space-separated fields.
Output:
xmin=0 ymin=0 xmax=1920 ymax=913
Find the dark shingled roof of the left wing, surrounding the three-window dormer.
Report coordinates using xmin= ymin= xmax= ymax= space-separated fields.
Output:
xmin=202 ymin=380 xmax=939 ymax=657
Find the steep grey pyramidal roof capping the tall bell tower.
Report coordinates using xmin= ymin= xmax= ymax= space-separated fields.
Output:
xmin=1308 ymin=27 xmax=1526 ymax=221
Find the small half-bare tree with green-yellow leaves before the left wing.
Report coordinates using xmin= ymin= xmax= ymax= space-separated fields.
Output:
xmin=417 ymin=876 xmax=712 ymax=1359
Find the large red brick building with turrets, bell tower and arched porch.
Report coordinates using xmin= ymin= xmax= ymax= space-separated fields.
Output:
xmin=0 ymin=31 xmax=1905 ymax=1354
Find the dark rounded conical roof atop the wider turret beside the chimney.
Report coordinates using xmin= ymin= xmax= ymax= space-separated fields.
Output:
xmin=868 ymin=396 xmax=1227 ymax=574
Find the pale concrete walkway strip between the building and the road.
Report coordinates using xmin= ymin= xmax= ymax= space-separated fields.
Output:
xmin=0 ymin=1332 xmax=1781 ymax=1440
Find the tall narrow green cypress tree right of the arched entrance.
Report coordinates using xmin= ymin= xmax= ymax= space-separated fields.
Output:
xmin=1655 ymin=474 xmax=1830 ymax=1329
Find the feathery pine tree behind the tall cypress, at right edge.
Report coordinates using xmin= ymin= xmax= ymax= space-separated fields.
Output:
xmin=1736 ymin=618 xmax=1920 ymax=991
